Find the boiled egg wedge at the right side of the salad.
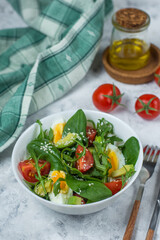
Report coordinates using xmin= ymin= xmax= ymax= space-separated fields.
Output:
xmin=106 ymin=143 xmax=125 ymax=177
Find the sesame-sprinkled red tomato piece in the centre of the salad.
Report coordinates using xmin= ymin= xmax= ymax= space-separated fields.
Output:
xmin=75 ymin=145 xmax=94 ymax=173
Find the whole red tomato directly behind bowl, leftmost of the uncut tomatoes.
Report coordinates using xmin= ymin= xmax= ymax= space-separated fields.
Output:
xmin=92 ymin=83 xmax=123 ymax=112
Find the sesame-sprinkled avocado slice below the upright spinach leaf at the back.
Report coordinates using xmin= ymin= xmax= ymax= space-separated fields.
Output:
xmin=55 ymin=133 xmax=77 ymax=149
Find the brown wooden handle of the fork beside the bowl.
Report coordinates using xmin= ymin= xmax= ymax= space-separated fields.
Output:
xmin=123 ymin=184 xmax=144 ymax=240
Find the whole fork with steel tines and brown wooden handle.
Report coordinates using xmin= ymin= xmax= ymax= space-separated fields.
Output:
xmin=123 ymin=146 xmax=160 ymax=240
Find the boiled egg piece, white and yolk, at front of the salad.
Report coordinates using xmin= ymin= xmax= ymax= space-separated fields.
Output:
xmin=49 ymin=170 xmax=73 ymax=204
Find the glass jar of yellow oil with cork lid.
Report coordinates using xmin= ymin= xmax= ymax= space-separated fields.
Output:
xmin=109 ymin=8 xmax=150 ymax=70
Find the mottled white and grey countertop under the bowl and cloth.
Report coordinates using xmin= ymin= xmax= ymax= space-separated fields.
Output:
xmin=0 ymin=0 xmax=160 ymax=240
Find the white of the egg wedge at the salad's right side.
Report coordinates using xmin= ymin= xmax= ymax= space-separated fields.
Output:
xmin=106 ymin=143 xmax=125 ymax=169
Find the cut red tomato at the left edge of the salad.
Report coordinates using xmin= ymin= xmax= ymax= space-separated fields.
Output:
xmin=18 ymin=159 xmax=51 ymax=183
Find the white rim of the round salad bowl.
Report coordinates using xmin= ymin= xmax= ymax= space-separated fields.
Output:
xmin=11 ymin=109 xmax=143 ymax=209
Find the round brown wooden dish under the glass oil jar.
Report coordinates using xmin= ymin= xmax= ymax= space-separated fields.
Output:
xmin=102 ymin=44 xmax=160 ymax=84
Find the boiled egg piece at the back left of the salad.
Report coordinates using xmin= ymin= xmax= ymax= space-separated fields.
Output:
xmin=52 ymin=119 xmax=66 ymax=143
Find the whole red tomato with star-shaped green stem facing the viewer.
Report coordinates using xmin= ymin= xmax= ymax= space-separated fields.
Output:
xmin=135 ymin=94 xmax=160 ymax=120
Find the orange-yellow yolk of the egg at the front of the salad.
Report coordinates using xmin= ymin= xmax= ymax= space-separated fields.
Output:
xmin=51 ymin=171 xmax=69 ymax=193
